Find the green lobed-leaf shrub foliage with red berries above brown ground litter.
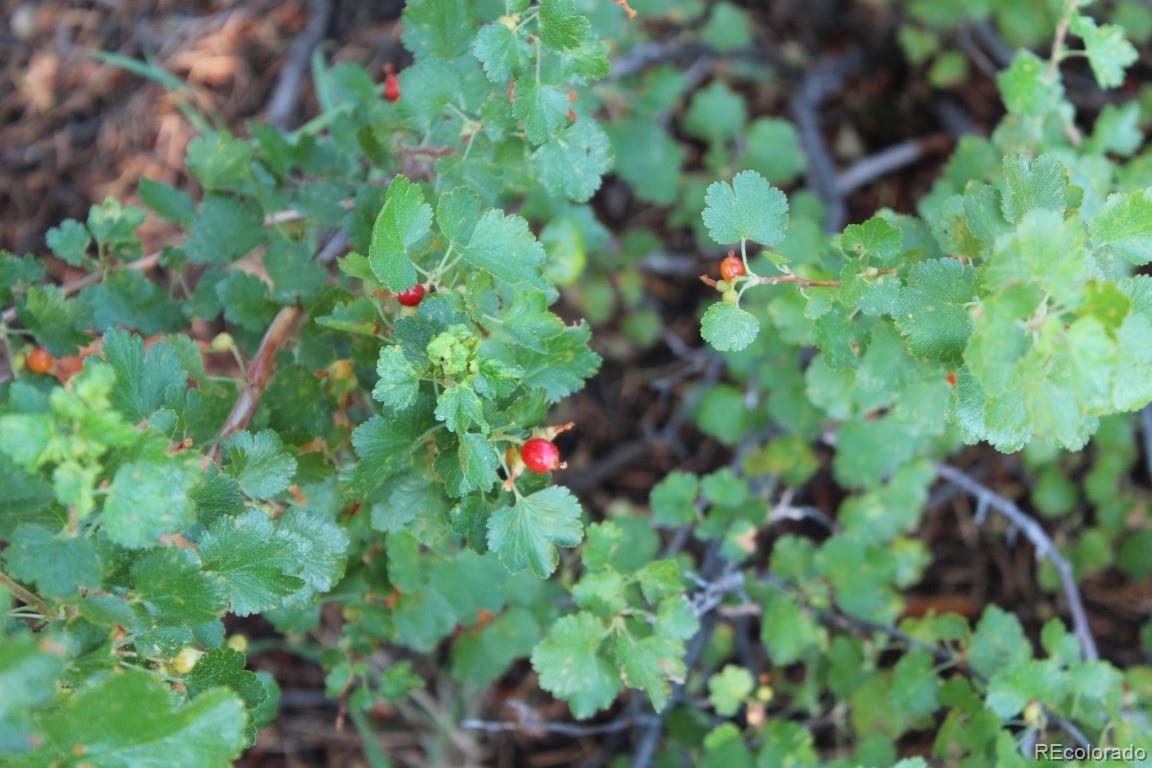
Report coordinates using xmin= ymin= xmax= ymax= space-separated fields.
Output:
xmin=0 ymin=0 xmax=1152 ymax=768
